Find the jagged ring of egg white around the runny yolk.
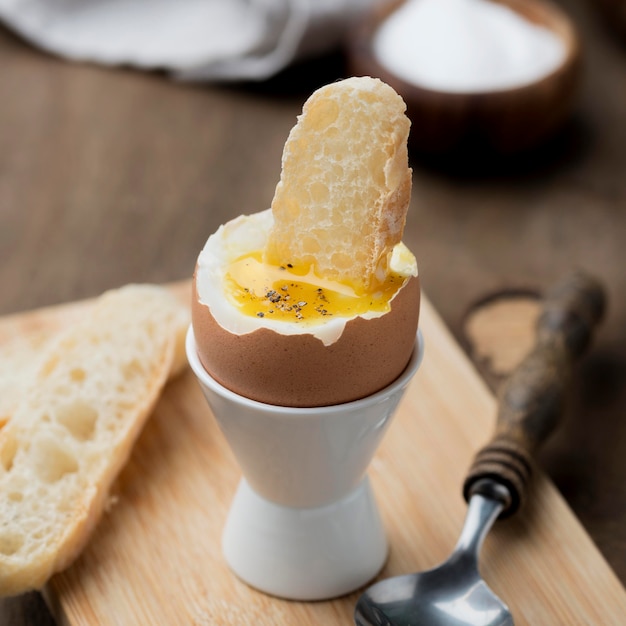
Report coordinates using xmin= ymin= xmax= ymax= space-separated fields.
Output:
xmin=196 ymin=209 xmax=418 ymax=346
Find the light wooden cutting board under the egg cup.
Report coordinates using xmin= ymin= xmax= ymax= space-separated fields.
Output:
xmin=0 ymin=284 xmax=626 ymax=626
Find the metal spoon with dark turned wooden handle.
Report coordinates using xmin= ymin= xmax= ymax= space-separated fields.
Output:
xmin=354 ymin=272 xmax=605 ymax=626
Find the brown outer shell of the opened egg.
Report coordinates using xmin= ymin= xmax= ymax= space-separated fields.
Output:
xmin=191 ymin=276 xmax=420 ymax=407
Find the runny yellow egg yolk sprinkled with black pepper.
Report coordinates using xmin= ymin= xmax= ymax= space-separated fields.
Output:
xmin=225 ymin=252 xmax=408 ymax=324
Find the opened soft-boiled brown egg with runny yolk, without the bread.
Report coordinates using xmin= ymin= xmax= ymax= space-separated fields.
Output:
xmin=192 ymin=209 xmax=420 ymax=407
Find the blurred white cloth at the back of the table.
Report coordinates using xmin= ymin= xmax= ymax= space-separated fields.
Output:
xmin=0 ymin=0 xmax=378 ymax=80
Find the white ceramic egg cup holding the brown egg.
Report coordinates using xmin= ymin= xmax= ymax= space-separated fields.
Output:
xmin=186 ymin=328 xmax=424 ymax=600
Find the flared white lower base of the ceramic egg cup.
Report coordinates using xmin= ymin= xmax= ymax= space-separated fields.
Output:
xmin=222 ymin=477 xmax=388 ymax=601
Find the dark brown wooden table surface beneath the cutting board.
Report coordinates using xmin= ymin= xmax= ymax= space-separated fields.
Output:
xmin=0 ymin=0 xmax=626 ymax=626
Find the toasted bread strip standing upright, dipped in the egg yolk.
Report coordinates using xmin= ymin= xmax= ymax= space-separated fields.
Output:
xmin=266 ymin=77 xmax=411 ymax=291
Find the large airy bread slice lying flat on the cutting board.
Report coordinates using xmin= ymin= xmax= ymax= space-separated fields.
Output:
xmin=0 ymin=285 xmax=189 ymax=596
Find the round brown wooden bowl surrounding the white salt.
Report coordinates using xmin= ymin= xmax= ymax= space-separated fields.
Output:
xmin=347 ymin=0 xmax=581 ymax=156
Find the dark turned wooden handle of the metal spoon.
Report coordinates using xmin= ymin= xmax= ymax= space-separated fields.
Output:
xmin=463 ymin=272 xmax=606 ymax=517
